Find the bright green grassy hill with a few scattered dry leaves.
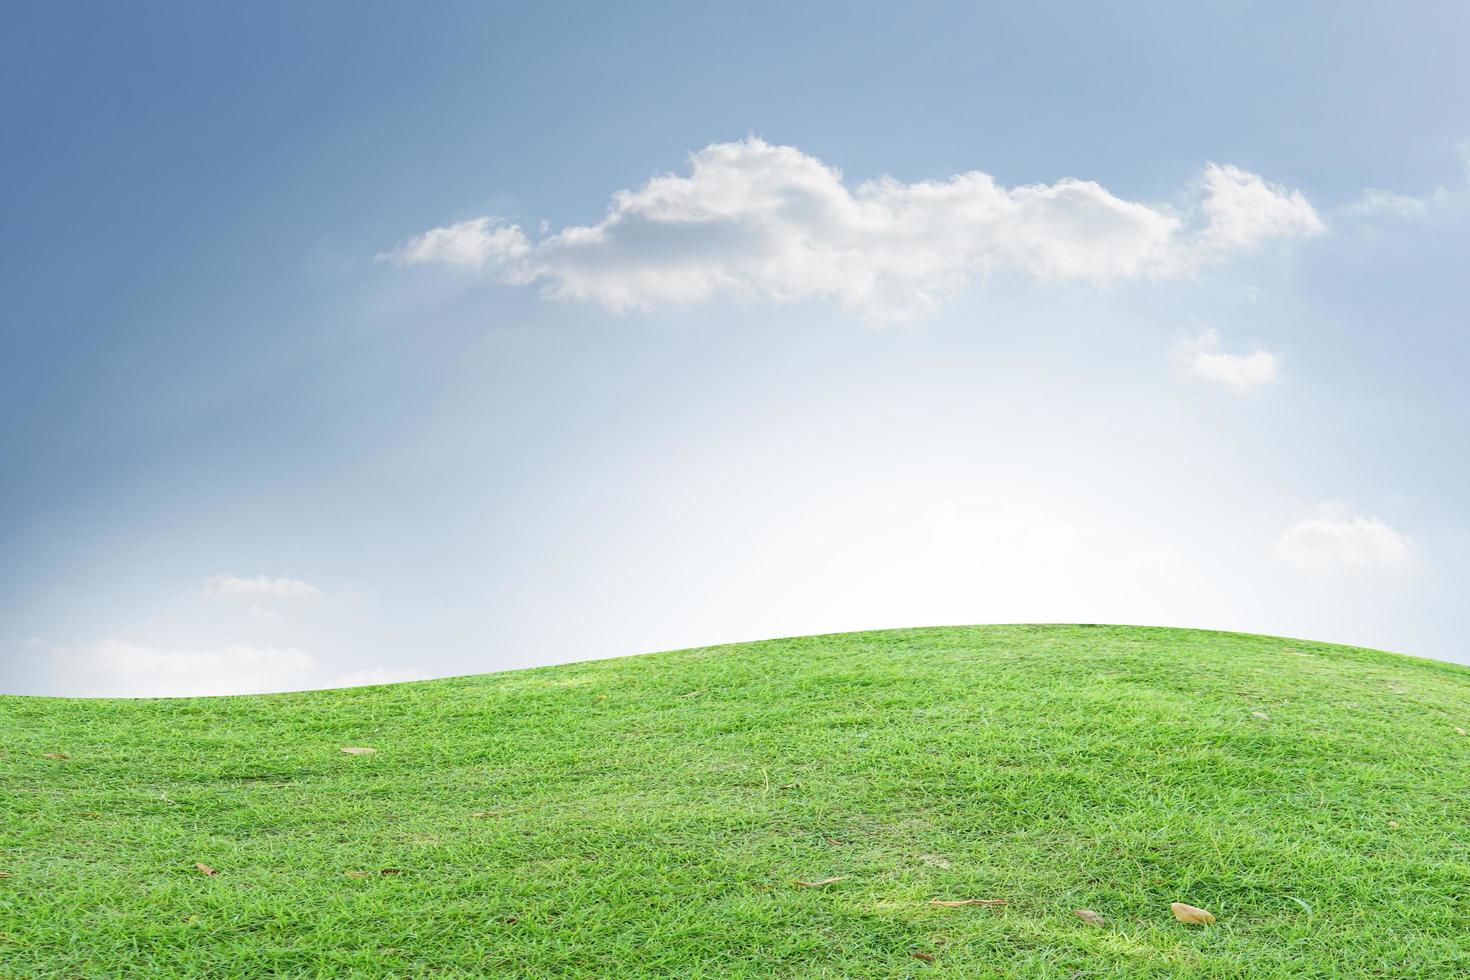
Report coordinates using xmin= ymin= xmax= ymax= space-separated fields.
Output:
xmin=0 ymin=626 xmax=1470 ymax=977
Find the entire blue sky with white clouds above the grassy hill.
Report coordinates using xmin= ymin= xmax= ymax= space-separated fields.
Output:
xmin=0 ymin=3 xmax=1470 ymax=693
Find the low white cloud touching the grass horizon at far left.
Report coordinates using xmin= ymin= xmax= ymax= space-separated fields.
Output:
xmin=53 ymin=639 xmax=316 ymax=698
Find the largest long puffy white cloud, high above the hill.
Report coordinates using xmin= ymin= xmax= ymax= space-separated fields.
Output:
xmin=381 ymin=138 xmax=1323 ymax=320
